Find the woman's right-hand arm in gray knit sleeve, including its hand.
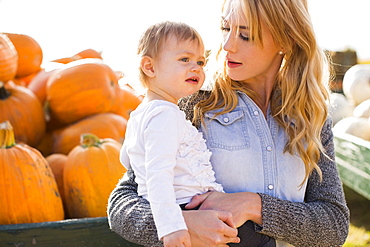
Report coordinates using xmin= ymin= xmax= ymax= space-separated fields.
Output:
xmin=187 ymin=117 xmax=349 ymax=246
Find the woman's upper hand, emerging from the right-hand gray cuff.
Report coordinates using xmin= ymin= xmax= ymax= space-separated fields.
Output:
xmin=186 ymin=192 xmax=262 ymax=227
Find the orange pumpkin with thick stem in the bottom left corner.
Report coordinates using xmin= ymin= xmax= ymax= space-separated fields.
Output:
xmin=0 ymin=121 xmax=64 ymax=224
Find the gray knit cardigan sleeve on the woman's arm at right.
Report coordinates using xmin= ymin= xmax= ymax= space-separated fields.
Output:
xmin=260 ymin=119 xmax=349 ymax=246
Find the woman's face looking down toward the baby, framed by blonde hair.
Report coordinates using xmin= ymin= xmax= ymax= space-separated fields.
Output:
xmin=221 ymin=0 xmax=283 ymax=83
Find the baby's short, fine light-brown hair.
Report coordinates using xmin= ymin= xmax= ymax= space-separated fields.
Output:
xmin=137 ymin=21 xmax=204 ymax=87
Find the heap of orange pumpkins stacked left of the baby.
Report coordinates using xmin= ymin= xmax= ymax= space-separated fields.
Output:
xmin=0 ymin=33 xmax=142 ymax=224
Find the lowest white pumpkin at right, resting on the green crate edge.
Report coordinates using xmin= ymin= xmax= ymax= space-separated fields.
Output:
xmin=333 ymin=117 xmax=370 ymax=141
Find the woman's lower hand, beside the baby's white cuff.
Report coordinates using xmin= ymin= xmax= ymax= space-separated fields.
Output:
xmin=182 ymin=210 xmax=240 ymax=247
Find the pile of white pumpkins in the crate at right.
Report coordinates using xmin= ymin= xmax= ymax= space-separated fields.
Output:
xmin=330 ymin=64 xmax=370 ymax=141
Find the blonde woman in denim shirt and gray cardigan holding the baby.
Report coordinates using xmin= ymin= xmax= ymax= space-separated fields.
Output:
xmin=108 ymin=0 xmax=349 ymax=246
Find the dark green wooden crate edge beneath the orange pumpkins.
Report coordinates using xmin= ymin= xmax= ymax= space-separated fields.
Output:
xmin=0 ymin=217 xmax=140 ymax=247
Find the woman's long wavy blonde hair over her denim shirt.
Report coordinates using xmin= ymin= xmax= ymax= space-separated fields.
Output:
xmin=194 ymin=0 xmax=329 ymax=184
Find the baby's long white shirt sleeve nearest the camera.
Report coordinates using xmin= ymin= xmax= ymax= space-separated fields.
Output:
xmin=144 ymin=107 xmax=187 ymax=239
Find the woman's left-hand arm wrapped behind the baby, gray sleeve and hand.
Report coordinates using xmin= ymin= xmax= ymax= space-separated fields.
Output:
xmin=108 ymin=169 xmax=239 ymax=247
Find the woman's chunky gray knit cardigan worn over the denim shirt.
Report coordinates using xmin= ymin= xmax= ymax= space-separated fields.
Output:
xmin=108 ymin=90 xmax=349 ymax=247
